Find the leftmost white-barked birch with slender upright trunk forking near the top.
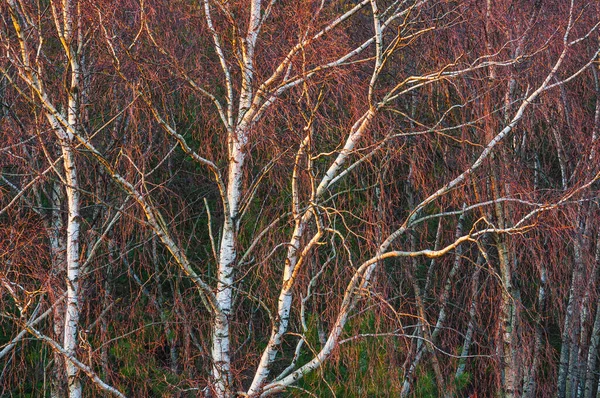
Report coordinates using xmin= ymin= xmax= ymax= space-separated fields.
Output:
xmin=5 ymin=1 xmax=83 ymax=397
